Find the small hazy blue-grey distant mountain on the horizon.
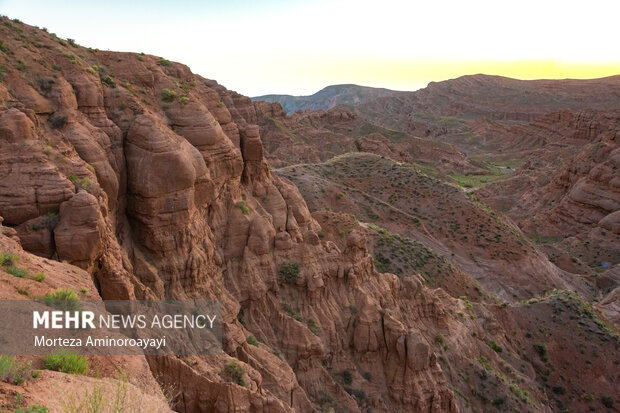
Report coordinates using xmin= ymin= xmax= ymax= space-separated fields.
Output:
xmin=252 ymin=84 xmax=403 ymax=113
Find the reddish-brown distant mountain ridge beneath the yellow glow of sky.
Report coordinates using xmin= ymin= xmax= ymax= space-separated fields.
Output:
xmin=356 ymin=75 xmax=620 ymax=130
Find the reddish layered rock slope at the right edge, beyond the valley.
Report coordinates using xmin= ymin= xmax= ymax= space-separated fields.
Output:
xmin=481 ymin=111 xmax=620 ymax=271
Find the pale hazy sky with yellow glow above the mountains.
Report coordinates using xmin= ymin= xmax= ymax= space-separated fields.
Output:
xmin=0 ymin=0 xmax=620 ymax=96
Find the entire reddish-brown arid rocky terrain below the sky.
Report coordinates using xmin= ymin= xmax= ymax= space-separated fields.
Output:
xmin=0 ymin=17 xmax=620 ymax=413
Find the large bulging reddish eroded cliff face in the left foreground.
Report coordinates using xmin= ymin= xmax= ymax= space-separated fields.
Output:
xmin=0 ymin=22 xmax=457 ymax=412
